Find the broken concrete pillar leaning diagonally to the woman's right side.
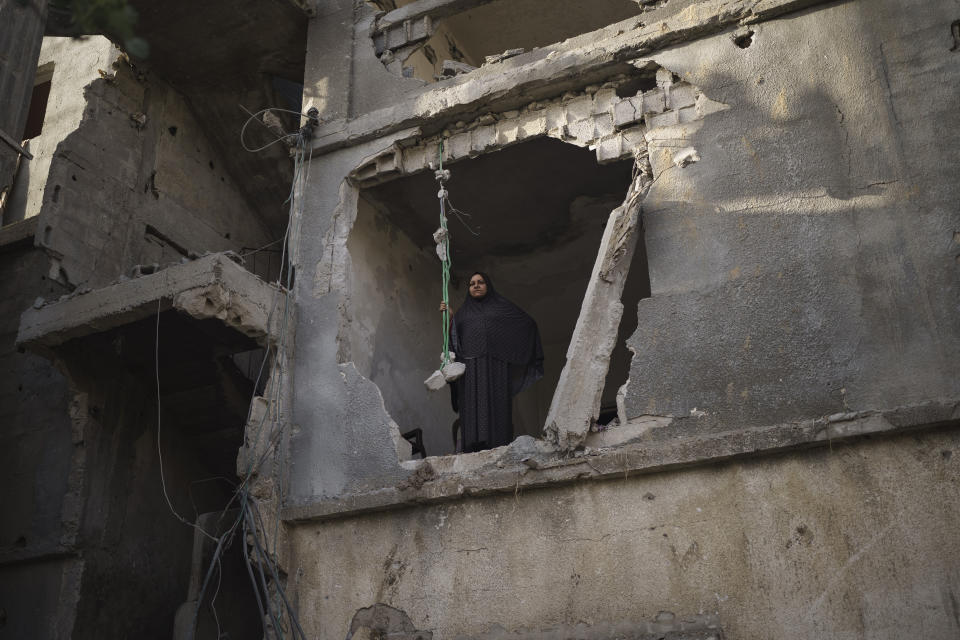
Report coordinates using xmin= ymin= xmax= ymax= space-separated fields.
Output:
xmin=544 ymin=162 xmax=652 ymax=451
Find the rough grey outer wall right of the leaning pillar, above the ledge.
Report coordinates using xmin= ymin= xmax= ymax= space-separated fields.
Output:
xmin=626 ymin=2 xmax=960 ymax=437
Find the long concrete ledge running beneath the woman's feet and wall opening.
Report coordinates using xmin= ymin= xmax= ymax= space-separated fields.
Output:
xmin=281 ymin=400 xmax=960 ymax=522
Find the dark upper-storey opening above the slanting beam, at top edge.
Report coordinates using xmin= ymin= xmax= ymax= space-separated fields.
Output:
xmin=381 ymin=0 xmax=641 ymax=82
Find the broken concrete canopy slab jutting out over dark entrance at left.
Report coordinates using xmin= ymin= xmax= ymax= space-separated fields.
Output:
xmin=17 ymin=253 xmax=286 ymax=348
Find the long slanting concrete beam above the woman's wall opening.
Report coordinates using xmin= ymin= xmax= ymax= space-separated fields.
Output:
xmin=313 ymin=0 xmax=825 ymax=154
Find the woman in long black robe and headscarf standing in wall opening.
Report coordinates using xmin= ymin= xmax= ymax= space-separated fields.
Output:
xmin=441 ymin=271 xmax=543 ymax=452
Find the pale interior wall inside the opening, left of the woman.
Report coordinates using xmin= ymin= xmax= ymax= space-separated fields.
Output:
xmin=341 ymin=196 xmax=456 ymax=455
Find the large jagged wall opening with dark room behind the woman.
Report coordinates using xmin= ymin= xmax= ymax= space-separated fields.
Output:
xmin=343 ymin=138 xmax=649 ymax=455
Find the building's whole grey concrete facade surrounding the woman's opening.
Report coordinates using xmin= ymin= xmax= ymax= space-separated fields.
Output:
xmin=283 ymin=0 xmax=960 ymax=640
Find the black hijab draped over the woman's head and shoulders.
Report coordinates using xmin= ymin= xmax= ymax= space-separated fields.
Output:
xmin=453 ymin=271 xmax=543 ymax=395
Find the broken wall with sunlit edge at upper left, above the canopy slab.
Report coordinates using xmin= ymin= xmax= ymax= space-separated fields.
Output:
xmin=5 ymin=36 xmax=271 ymax=287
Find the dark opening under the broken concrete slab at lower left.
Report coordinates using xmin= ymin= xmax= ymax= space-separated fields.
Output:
xmin=59 ymin=310 xmax=269 ymax=639
